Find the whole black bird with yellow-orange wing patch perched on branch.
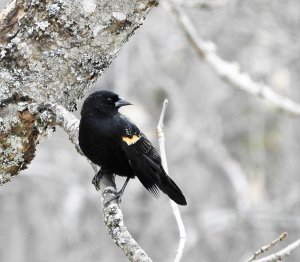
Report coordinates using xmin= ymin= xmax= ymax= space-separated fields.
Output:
xmin=79 ymin=90 xmax=187 ymax=205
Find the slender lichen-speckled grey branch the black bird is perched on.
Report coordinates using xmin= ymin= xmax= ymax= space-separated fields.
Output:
xmin=51 ymin=105 xmax=152 ymax=262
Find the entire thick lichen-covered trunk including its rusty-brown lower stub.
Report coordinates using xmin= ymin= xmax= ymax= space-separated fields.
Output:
xmin=0 ymin=0 xmax=157 ymax=185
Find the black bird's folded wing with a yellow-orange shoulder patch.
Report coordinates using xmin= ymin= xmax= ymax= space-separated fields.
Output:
xmin=121 ymin=118 xmax=163 ymax=197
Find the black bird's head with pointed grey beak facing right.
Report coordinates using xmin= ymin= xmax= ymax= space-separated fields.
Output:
xmin=81 ymin=90 xmax=131 ymax=115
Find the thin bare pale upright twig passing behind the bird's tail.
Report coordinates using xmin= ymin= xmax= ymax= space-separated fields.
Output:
xmin=156 ymin=99 xmax=186 ymax=262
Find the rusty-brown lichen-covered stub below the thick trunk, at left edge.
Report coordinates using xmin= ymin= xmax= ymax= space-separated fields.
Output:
xmin=0 ymin=94 xmax=56 ymax=185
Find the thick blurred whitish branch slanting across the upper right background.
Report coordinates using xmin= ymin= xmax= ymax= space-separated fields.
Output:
xmin=162 ymin=0 xmax=300 ymax=116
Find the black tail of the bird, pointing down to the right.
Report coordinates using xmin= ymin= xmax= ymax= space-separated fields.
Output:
xmin=159 ymin=173 xmax=187 ymax=206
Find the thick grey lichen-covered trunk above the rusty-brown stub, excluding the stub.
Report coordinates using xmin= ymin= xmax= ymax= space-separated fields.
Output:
xmin=0 ymin=0 xmax=156 ymax=109
